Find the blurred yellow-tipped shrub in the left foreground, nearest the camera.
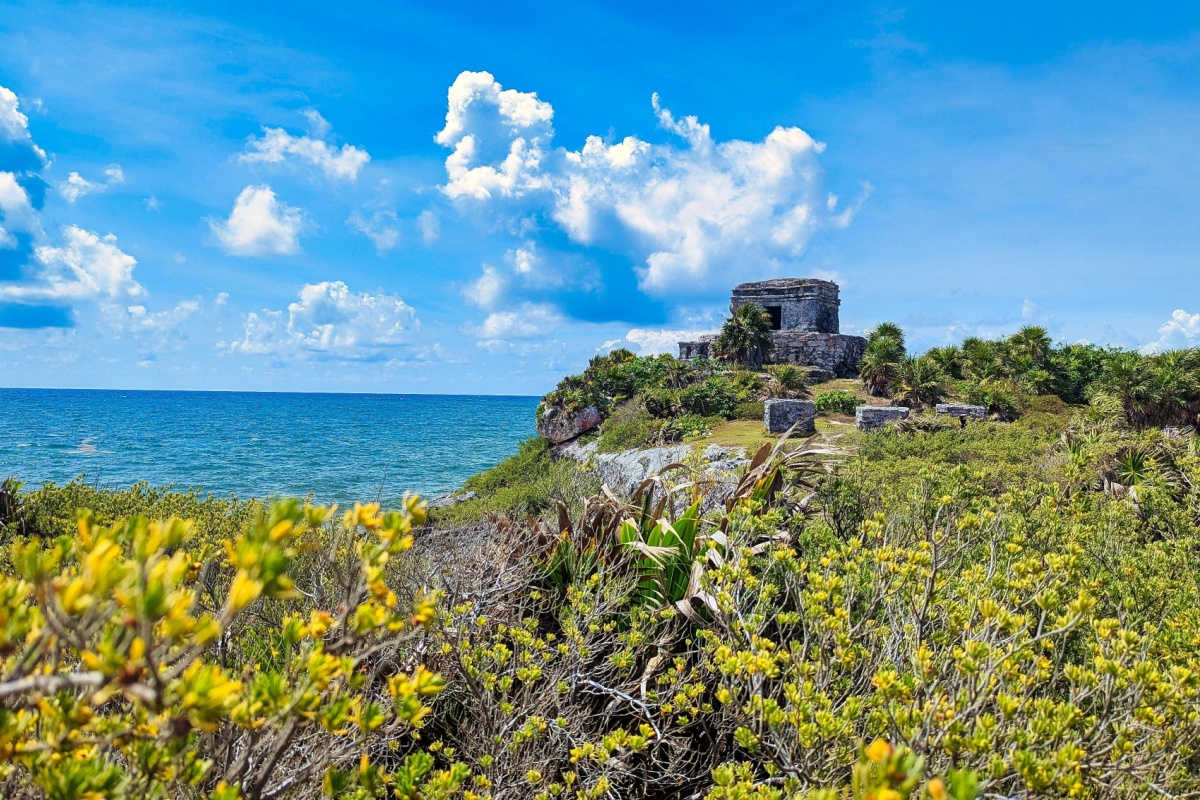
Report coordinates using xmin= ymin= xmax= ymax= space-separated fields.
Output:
xmin=0 ymin=499 xmax=466 ymax=800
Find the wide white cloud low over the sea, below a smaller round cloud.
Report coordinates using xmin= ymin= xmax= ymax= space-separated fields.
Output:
xmin=227 ymin=281 xmax=420 ymax=361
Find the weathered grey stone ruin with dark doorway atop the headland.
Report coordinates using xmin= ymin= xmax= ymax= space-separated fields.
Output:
xmin=679 ymin=278 xmax=866 ymax=378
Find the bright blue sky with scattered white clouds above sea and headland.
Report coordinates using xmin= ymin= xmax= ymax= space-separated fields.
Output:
xmin=0 ymin=0 xmax=1200 ymax=395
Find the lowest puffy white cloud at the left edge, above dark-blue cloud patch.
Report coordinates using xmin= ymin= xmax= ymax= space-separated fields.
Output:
xmin=0 ymin=225 xmax=145 ymax=302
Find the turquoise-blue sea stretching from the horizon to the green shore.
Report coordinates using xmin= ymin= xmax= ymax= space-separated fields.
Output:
xmin=0 ymin=389 xmax=538 ymax=504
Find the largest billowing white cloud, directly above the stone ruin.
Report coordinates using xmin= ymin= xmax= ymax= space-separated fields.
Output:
xmin=436 ymin=72 xmax=866 ymax=296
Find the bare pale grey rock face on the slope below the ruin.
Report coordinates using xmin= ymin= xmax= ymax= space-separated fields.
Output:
xmin=554 ymin=441 xmax=750 ymax=500
